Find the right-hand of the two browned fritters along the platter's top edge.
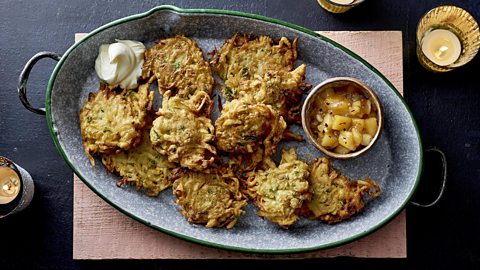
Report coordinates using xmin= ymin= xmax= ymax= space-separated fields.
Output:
xmin=211 ymin=34 xmax=297 ymax=89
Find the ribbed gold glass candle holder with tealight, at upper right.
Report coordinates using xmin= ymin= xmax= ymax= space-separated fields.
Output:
xmin=417 ymin=6 xmax=480 ymax=72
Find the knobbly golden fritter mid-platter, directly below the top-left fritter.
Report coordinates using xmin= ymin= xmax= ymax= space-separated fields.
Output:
xmin=150 ymin=91 xmax=217 ymax=171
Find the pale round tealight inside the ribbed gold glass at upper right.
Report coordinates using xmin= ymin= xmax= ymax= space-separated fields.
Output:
xmin=422 ymin=29 xmax=462 ymax=66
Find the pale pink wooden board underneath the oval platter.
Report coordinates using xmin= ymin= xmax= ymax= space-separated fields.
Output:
xmin=73 ymin=31 xmax=407 ymax=260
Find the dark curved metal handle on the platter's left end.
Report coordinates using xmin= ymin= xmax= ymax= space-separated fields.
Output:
xmin=17 ymin=52 xmax=62 ymax=115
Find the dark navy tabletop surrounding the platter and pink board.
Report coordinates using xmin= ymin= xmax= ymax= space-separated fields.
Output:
xmin=0 ymin=0 xmax=480 ymax=269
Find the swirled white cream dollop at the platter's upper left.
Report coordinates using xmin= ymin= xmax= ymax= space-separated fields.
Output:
xmin=95 ymin=39 xmax=145 ymax=89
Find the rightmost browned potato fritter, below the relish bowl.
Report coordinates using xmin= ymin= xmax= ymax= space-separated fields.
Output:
xmin=305 ymin=158 xmax=380 ymax=224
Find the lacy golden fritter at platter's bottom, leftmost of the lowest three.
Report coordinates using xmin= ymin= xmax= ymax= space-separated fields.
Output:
xmin=173 ymin=169 xmax=247 ymax=229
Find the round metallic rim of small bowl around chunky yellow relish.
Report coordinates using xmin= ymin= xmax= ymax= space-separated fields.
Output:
xmin=302 ymin=77 xmax=383 ymax=159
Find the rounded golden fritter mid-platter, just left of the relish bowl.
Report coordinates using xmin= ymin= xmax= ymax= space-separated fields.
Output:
xmin=215 ymin=99 xmax=287 ymax=156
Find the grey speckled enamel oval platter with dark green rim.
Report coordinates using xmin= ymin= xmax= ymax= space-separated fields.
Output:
xmin=46 ymin=6 xmax=422 ymax=253
